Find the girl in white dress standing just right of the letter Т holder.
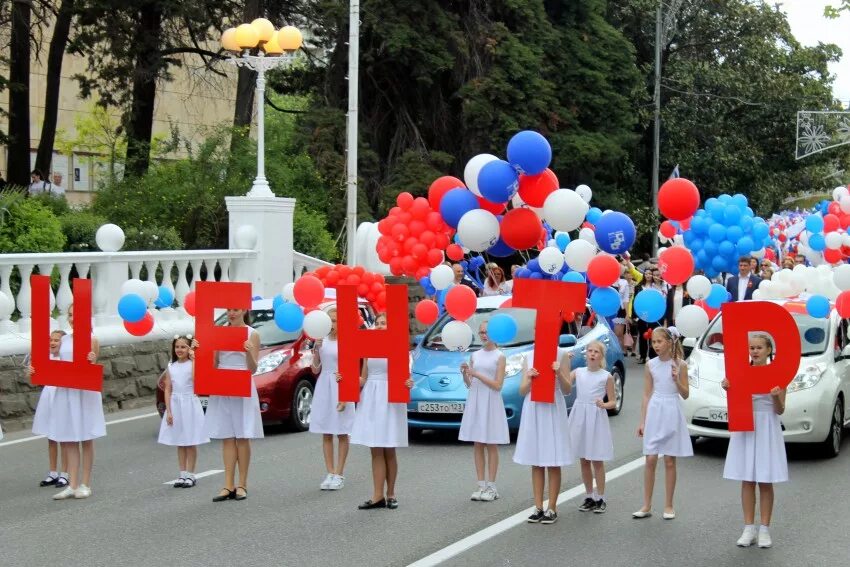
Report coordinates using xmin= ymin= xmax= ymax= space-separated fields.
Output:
xmin=569 ymin=341 xmax=617 ymax=514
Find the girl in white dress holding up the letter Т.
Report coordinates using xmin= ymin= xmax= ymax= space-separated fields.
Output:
xmin=514 ymin=355 xmax=575 ymax=524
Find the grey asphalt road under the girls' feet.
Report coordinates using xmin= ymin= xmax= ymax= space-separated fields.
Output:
xmin=0 ymin=363 xmax=850 ymax=567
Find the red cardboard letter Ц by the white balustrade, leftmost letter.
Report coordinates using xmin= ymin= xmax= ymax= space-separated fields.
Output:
xmin=30 ymin=276 xmax=103 ymax=392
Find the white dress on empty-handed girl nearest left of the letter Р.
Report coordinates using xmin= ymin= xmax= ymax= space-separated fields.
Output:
xmin=643 ymin=357 xmax=694 ymax=457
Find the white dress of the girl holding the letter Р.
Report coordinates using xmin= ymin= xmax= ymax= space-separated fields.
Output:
xmin=723 ymin=394 xmax=788 ymax=482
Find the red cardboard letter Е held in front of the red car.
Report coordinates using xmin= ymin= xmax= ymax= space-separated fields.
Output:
xmin=195 ymin=282 xmax=251 ymax=398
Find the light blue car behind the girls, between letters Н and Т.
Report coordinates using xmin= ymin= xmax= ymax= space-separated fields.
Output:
xmin=407 ymin=297 xmax=626 ymax=431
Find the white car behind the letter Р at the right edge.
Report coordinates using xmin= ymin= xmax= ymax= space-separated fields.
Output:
xmin=683 ymin=300 xmax=850 ymax=457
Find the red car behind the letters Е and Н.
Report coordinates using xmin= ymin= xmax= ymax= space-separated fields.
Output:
xmin=156 ymin=296 xmax=374 ymax=431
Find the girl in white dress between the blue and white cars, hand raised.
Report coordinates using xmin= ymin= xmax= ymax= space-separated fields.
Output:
xmin=632 ymin=327 xmax=694 ymax=520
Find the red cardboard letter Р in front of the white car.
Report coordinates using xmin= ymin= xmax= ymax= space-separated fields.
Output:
xmin=722 ymin=301 xmax=801 ymax=431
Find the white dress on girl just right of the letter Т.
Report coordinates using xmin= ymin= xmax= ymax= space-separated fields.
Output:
xmin=570 ymin=368 xmax=614 ymax=461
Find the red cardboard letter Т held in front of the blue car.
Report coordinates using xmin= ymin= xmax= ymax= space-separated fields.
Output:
xmin=512 ymin=278 xmax=587 ymax=403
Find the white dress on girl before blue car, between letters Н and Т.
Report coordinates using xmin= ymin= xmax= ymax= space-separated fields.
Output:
xmin=458 ymin=349 xmax=511 ymax=445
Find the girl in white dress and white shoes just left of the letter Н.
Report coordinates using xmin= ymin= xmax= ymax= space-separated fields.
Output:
xmin=310 ymin=308 xmax=354 ymax=490
